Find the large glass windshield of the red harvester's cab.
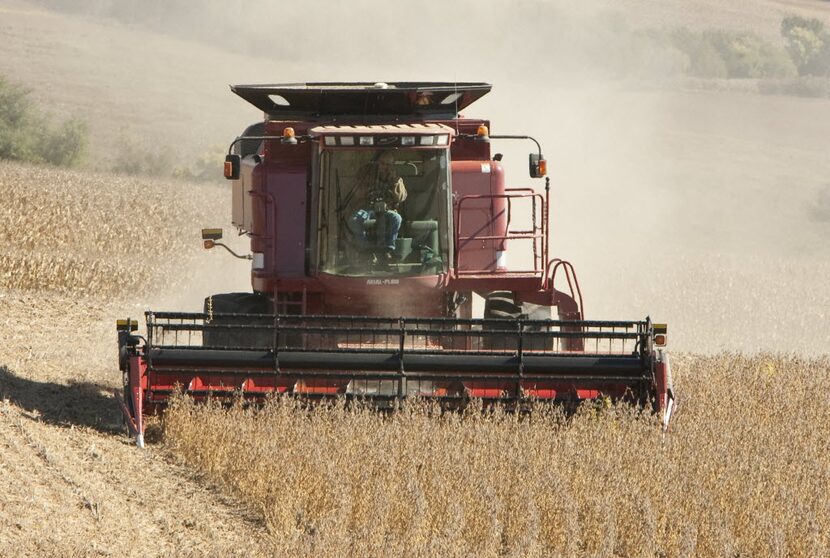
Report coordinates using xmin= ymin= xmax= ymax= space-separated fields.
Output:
xmin=319 ymin=148 xmax=450 ymax=276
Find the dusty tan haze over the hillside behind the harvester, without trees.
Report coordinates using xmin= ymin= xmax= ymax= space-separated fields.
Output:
xmin=0 ymin=0 xmax=830 ymax=352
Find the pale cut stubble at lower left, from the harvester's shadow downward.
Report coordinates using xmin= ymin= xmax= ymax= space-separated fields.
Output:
xmin=0 ymin=400 xmax=271 ymax=557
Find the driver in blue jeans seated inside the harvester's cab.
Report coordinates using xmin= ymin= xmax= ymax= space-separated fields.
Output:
xmin=348 ymin=151 xmax=407 ymax=264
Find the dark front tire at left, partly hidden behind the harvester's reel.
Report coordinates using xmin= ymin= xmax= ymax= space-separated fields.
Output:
xmin=202 ymin=293 xmax=274 ymax=348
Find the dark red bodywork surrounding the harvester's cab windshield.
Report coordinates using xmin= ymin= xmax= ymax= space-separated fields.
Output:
xmin=234 ymin=118 xmax=544 ymax=316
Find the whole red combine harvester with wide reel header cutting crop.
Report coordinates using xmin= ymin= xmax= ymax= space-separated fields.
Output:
xmin=118 ymin=82 xmax=674 ymax=445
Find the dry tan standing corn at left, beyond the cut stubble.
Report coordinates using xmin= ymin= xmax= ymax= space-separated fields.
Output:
xmin=0 ymin=164 xmax=225 ymax=296
